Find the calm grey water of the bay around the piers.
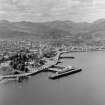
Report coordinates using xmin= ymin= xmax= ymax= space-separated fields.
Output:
xmin=0 ymin=52 xmax=105 ymax=105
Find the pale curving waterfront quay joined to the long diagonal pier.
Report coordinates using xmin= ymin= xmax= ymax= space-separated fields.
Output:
xmin=0 ymin=50 xmax=81 ymax=81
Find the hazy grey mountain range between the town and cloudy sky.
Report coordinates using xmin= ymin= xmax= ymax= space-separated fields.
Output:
xmin=0 ymin=19 xmax=105 ymax=46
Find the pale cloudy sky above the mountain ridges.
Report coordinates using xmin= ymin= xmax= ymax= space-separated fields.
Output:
xmin=0 ymin=0 xmax=105 ymax=22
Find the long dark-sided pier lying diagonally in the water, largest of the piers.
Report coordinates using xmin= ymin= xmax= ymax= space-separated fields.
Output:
xmin=49 ymin=67 xmax=82 ymax=79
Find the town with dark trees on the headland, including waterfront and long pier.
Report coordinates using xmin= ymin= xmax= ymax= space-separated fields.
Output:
xmin=0 ymin=41 xmax=81 ymax=81
